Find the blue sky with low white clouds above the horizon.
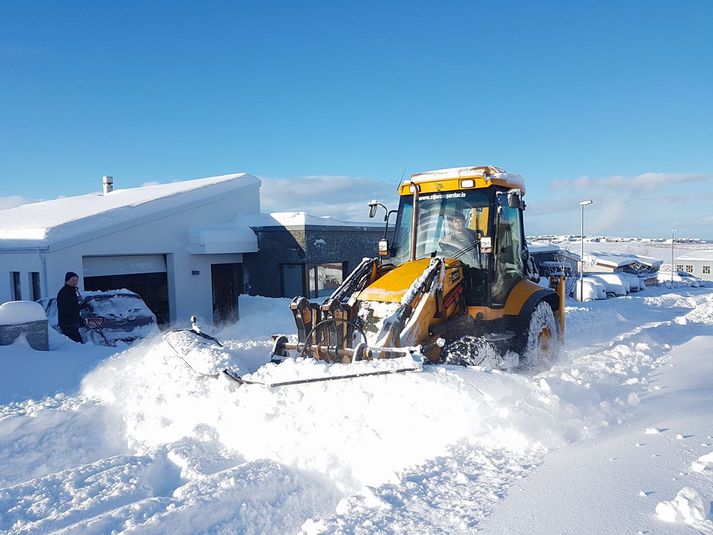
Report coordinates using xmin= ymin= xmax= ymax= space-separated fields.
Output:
xmin=0 ymin=0 xmax=713 ymax=239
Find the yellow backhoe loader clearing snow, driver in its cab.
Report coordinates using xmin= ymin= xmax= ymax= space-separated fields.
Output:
xmin=274 ymin=165 xmax=564 ymax=371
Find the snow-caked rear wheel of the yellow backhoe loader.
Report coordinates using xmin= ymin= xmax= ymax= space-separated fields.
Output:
xmin=520 ymin=301 xmax=560 ymax=368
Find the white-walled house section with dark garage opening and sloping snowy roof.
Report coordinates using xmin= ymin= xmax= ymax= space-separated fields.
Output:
xmin=0 ymin=173 xmax=260 ymax=323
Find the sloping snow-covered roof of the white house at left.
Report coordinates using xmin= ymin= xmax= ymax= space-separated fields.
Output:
xmin=0 ymin=173 xmax=260 ymax=248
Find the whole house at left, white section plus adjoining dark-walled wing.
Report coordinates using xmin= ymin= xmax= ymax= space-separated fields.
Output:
xmin=0 ymin=173 xmax=381 ymax=325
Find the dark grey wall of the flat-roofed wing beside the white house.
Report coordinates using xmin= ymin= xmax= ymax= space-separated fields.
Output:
xmin=243 ymin=226 xmax=383 ymax=297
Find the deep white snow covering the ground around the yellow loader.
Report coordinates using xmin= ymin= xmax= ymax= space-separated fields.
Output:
xmin=0 ymin=288 xmax=713 ymax=534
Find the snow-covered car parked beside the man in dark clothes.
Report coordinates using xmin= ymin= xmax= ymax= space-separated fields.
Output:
xmin=37 ymin=289 xmax=159 ymax=345
